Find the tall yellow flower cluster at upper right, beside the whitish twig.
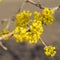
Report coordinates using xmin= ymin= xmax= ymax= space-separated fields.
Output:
xmin=42 ymin=8 xmax=54 ymax=25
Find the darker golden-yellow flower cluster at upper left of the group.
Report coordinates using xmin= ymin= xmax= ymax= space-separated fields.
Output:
xmin=16 ymin=11 xmax=32 ymax=27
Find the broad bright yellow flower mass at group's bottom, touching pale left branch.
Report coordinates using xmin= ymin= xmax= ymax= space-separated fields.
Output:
xmin=13 ymin=24 xmax=43 ymax=44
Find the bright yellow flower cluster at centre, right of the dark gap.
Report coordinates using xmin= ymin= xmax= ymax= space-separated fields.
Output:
xmin=30 ymin=20 xmax=43 ymax=37
